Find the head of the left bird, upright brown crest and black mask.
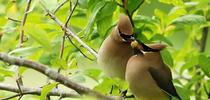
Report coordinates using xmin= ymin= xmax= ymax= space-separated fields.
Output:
xmin=117 ymin=14 xmax=135 ymax=42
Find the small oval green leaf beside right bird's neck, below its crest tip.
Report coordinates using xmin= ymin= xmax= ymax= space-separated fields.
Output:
xmin=161 ymin=49 xmax=174 ymax=67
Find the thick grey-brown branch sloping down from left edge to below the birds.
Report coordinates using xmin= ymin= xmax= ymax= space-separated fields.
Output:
xmin=0 ymin=53 xmax=113 ymax=100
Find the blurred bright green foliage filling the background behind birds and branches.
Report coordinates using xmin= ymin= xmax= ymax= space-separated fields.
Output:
xmin=0 ymin=0 xmax=210 ymax=100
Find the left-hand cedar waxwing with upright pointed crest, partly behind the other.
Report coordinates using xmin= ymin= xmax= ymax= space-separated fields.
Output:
xmin=97 ymin=15 xmax=134 ymax=79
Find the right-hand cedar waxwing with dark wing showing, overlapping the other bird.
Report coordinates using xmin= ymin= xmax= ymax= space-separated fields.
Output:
xmin=125 ymin=41 xmax=181 ymax=100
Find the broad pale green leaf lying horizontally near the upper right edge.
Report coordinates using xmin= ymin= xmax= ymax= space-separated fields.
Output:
xmin=171 ymin=15 xmax=206 ymax=25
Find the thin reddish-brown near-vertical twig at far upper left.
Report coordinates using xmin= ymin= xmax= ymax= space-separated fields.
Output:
xmin=18 ymin=0 xmax=32 ymax=47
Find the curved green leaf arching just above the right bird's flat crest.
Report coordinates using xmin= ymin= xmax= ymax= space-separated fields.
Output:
xmin=150 ymin=34 xmax=173 ymax=46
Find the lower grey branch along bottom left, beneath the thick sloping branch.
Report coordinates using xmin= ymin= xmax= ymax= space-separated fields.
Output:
xmin=0 ymin=83 xmax=80 ymax=100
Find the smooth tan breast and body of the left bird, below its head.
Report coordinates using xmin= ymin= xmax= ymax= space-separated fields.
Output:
xmin=97 ymin=36 xmax=133 ymax=79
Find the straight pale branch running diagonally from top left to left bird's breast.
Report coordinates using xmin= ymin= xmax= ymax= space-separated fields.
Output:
xmin=40 ymin=2 xmax=98 ymax=58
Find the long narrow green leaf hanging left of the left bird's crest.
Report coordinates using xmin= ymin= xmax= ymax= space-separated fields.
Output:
xmin=85 ymin=1 xmax=106 ymax=35
